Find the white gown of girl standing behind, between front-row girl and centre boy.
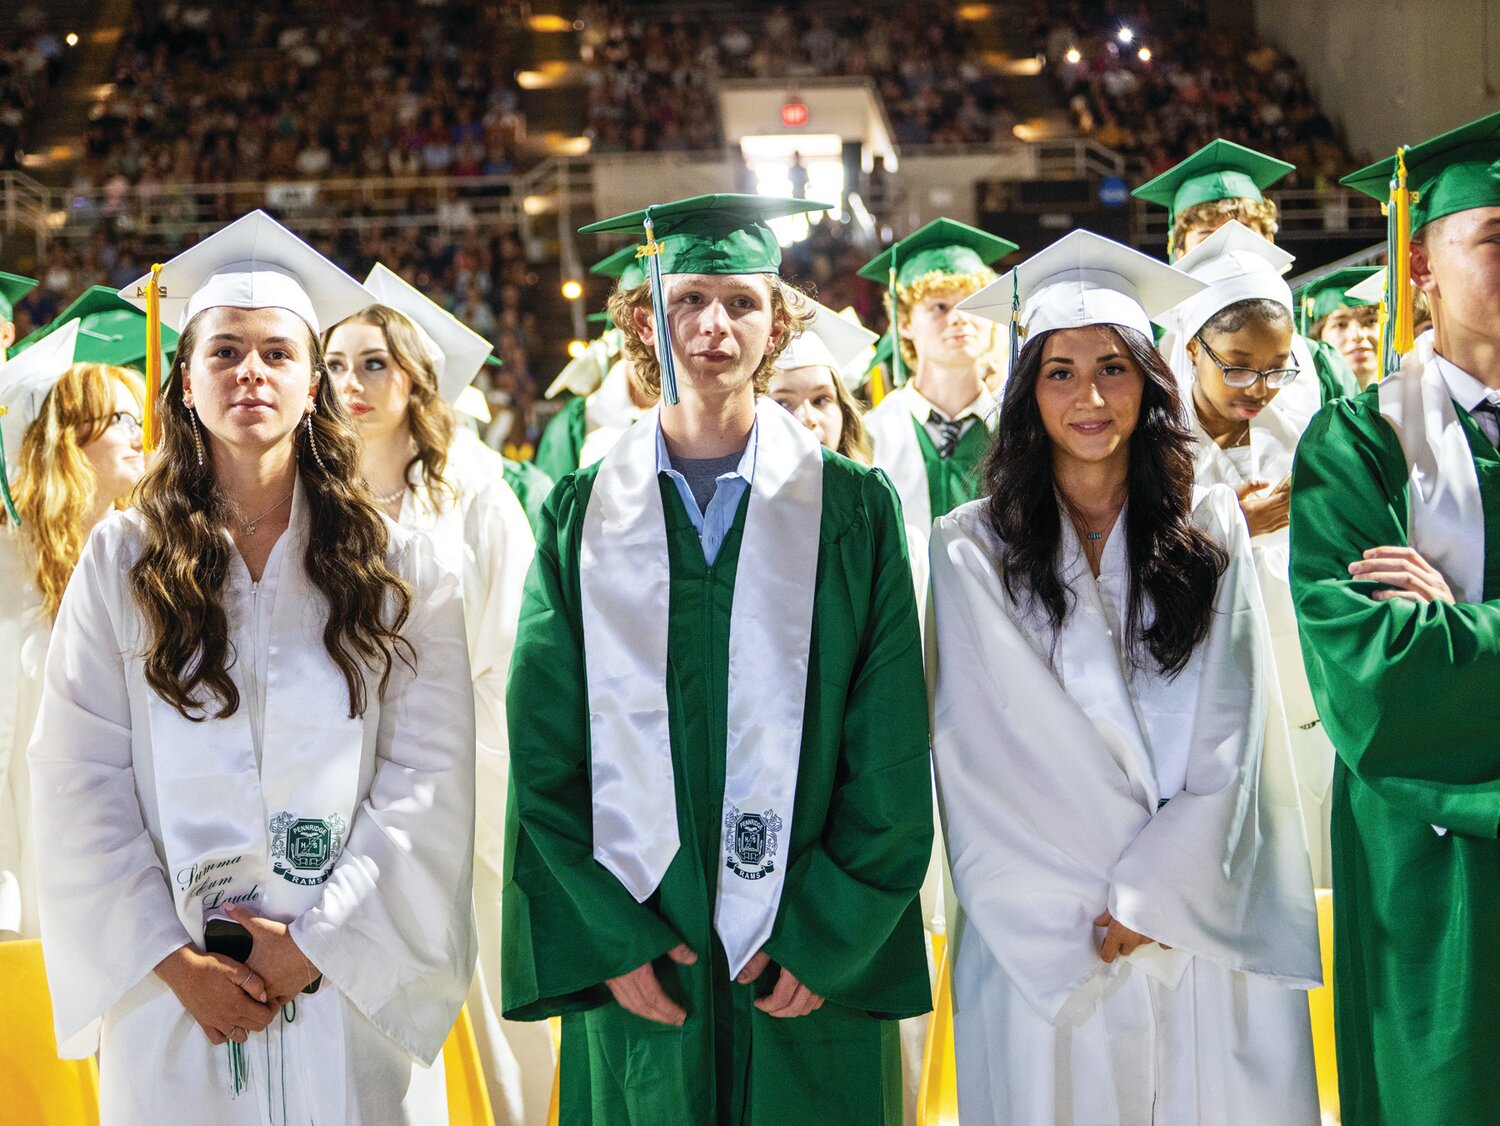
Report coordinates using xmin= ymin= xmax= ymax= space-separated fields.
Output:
xmin=401 ymin=432 xmax=555 ymax=1126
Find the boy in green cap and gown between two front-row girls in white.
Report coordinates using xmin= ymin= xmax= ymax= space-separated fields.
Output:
xmin=503 ymin=196 xmax=933 ymax=1126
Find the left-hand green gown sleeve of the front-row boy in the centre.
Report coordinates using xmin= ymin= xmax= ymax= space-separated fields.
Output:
xmin=501 ymin=478 xmax=681 ymax=1020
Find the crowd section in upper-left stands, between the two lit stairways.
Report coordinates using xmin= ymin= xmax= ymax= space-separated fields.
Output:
xmin=87 ymin=0 xmax=525 ymax=189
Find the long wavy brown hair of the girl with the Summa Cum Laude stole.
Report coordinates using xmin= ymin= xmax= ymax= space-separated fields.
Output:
xmin=131 ymin=313 xmax=416 ymax=720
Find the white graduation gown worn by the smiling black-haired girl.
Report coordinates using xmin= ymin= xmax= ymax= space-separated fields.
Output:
xmin=929 ymin=489 xmax=1320 ymax=1126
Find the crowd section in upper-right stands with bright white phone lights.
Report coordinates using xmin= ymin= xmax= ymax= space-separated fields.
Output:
xmin=1032 ymin=0 xmax=1361 ymax=187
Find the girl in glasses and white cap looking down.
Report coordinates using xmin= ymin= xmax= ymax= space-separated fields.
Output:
xmin=1166 ymin=222 xmax=1334 ymax=888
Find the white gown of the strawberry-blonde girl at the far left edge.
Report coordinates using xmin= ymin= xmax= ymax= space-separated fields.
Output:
xmin=0 ymin=525 xmax=53 ymax=942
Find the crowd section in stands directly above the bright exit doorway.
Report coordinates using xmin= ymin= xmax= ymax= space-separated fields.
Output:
xmin=579 ymin=0 xmax=1016 ymax=153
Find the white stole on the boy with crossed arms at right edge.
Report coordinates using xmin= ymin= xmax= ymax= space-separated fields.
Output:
xmin=1377 ymin=331 xmax=1485 ymax=603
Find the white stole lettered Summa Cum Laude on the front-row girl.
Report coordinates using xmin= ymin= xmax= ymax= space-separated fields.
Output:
xmin=147 ymin=478 xmax=367 ymax=946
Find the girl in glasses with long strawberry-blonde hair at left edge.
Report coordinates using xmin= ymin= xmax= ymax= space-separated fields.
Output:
xmin=0 ymin=330 xmax=146 ymax=939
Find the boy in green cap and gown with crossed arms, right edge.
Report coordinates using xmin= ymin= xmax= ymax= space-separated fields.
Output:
xmin=1292 ymin=107 xmax=1500 ymax=1126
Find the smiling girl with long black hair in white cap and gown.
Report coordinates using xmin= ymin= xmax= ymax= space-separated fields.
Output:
xmin=929 ymin=231 xmax=1320 ymax=1126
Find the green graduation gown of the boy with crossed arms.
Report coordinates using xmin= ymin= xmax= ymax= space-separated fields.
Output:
xmin=1292 ymin=387 xmax=1500 ymax=1126
